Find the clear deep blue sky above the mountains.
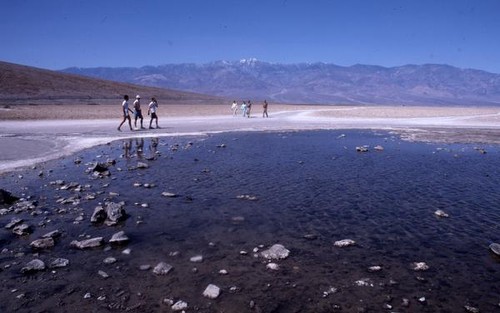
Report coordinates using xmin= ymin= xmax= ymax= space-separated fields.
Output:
xmin=0 ymin=0 xmax=500 ymax=73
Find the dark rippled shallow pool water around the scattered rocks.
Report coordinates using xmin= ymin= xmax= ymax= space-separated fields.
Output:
xmin=0 ymin=131 xmax=500 ymax=312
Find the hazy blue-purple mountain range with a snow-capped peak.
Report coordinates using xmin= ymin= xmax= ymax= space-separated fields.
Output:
xmin=63 ymin=59 xmax=500 ymax=106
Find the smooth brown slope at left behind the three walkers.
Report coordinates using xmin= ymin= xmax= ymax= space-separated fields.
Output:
xmin=0 ymin=62 xmax=220 ymax=104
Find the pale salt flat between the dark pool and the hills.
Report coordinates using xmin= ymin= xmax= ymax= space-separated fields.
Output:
xmin=0 ymin=103 xmax=500 ymax=173
